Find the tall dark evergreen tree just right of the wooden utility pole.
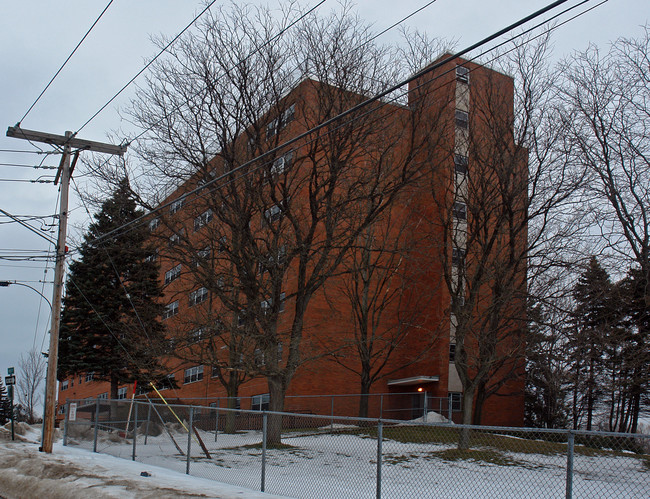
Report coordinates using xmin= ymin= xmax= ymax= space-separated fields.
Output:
xmin=58 ymin=179 xmax=164 ymax=398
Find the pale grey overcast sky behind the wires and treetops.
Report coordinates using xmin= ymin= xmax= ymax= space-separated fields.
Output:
xmin=0 ymin=0 xmax=650 ymax=390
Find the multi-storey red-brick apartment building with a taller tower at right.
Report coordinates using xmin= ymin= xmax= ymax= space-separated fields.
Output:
xmin=58 ymin=55 xmax=526 ymax=425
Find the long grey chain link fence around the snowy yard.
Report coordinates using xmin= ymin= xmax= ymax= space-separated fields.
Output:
xmin=64 ymin=400 xmax=650 ymax=498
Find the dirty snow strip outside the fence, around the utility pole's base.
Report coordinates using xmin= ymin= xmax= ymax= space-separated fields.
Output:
xmin=0 ymin=427 xmax=279 ymax=499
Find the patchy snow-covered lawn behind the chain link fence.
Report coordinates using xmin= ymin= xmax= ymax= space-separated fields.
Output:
xmin=55 ymin=418 xmax=650 ymax=499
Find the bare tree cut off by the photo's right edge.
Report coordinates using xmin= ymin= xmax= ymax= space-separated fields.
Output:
xmin=558 ymin=26 xmax=650 ymax=431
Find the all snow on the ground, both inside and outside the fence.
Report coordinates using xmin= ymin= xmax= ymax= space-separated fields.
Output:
xmin=0 ymin=416 xmax=650 ymax=499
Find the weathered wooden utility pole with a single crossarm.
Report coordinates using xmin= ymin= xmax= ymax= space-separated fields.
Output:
xmin=7 ymin=126 xmax=127 ymax=453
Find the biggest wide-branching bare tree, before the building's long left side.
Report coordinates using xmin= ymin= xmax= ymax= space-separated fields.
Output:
xmin=125 ymin=2 xmax=440 ymax=442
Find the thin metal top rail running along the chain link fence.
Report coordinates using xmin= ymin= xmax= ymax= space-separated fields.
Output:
xmin=62 ymin=399 xmax=650 ymax=439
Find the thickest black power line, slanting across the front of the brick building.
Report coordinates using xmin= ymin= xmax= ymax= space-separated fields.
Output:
xmin=90 ymin=0 xmax=580 ymax=248
